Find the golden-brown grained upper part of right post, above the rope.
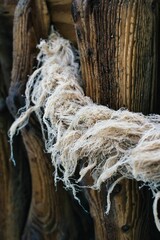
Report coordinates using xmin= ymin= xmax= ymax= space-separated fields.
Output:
xmin=73 ymin=0 xmax=160 ymax=114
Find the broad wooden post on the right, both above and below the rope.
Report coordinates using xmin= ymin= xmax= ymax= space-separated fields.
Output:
xmin=72 ymin=0 xmax=160 ymax=240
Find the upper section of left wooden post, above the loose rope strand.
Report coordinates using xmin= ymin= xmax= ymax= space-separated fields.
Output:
xmin=7 ymin=0 xmax=49 ymax=116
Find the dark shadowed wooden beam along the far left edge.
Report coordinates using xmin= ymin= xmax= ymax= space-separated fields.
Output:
xmin=0 ymin=0 xmax=31 ymax=240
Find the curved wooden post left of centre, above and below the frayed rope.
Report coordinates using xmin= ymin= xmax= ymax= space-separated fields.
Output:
xmin=5 ymin=0 xmax=92 ymax=240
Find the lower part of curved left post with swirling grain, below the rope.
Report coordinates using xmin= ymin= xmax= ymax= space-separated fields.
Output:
xmin=23 ymin=128 xmax=87 ymax=240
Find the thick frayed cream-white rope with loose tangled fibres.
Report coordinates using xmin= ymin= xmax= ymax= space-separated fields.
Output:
xmin=9 ymin=32 xmax=160 ymax=230
